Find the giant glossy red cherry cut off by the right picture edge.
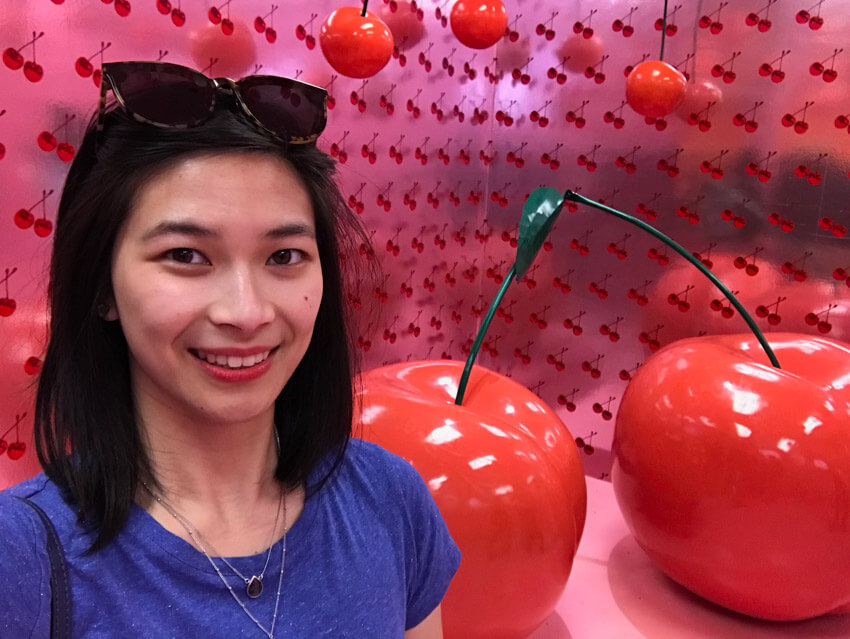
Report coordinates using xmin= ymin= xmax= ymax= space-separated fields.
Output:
xmin=612 ymin=333 xmax=850 ymax=620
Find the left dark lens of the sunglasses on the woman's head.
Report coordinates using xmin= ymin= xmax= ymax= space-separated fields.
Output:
xmin=107 ymin=63 xmax=215 ymax=126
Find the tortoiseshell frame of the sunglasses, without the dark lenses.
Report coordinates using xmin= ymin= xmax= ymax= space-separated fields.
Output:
xmin=96 ymin=61 xmax=328 ymax=144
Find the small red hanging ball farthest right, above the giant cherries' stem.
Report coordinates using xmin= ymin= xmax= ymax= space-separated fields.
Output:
xmin=626 ymin=60 xmax=687 ymax=118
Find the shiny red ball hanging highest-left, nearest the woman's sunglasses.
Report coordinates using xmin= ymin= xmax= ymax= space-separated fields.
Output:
xmin=319 ymin=7 xmax=393 ymax=78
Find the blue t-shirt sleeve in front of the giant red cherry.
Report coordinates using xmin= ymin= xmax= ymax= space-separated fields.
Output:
xmin=388 ymin=462 xmax=461 ymax=630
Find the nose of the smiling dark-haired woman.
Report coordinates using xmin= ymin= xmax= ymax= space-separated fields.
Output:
xmin=210 ymin=269 xmax=274 ymax=332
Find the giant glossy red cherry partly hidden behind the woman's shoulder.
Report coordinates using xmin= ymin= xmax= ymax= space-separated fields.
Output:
xmin=359 ymin=360 xmax=587 ymax=639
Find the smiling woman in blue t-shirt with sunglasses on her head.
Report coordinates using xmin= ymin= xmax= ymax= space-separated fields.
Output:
xmin=0 ymin=63 xmax=460 ymax=638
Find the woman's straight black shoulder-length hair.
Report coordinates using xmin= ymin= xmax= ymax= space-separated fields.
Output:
xmin=35 ymin=97 xmax=368 ymax=552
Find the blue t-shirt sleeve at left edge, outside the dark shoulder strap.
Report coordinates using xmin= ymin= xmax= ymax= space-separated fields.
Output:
xmin=0 ymin=493 xmax=50 ymax=639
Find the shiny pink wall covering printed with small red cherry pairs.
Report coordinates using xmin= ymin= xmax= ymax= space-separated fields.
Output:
xmin=0 ymin=0 xmax=850 ymax=488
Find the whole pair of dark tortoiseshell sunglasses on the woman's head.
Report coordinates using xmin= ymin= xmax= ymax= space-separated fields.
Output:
xmin=97 ymin=62 xmax=328 ymax=144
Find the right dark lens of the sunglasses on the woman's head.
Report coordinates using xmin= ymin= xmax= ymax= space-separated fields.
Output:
xmin=242 ymin=77 xmax=327 ymax=139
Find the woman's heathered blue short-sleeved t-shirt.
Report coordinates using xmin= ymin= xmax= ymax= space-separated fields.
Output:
xmin=0 ymin=439 xmax=460 ymax=639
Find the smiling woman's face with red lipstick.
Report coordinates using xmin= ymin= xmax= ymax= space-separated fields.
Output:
xmin=108 ymin=153 xmax=322 ymax=423
